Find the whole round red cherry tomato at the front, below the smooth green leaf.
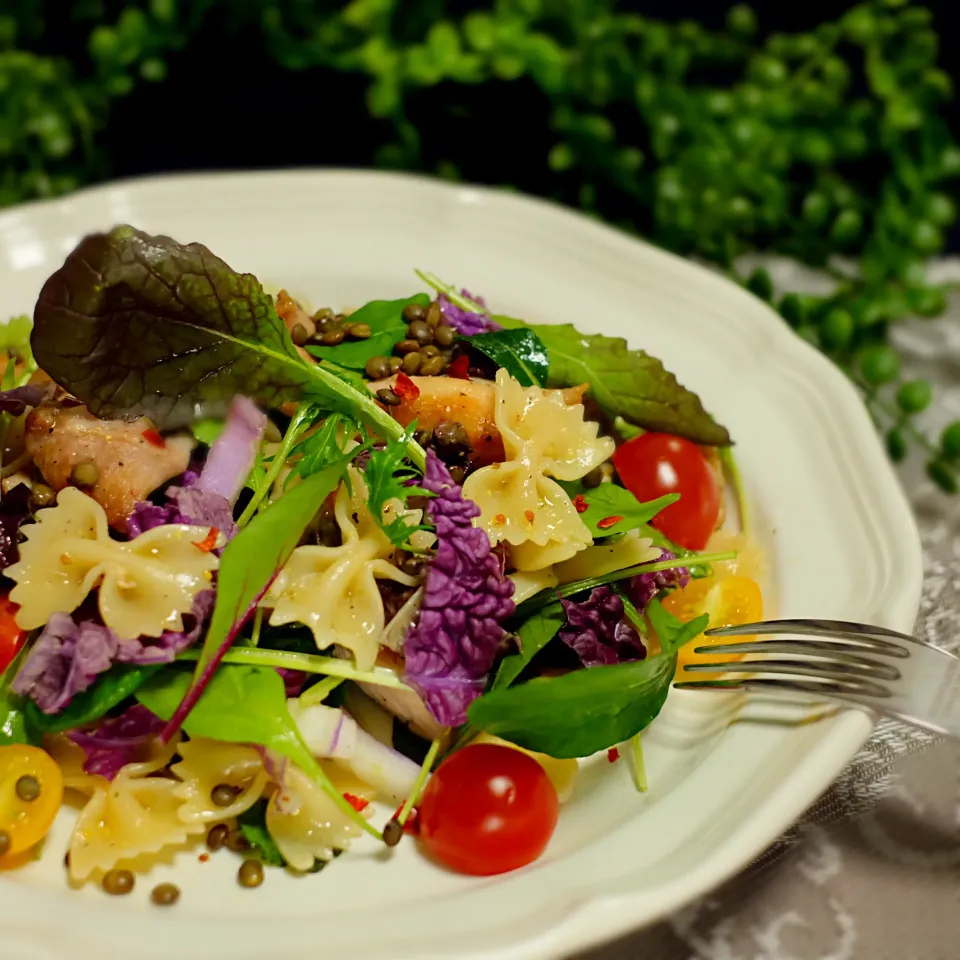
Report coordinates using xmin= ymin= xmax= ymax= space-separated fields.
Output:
xmin=419 ymin=743 xmax=560 ymax=876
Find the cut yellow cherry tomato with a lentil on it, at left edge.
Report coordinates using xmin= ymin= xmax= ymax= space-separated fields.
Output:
xmin=0 ymin=744 xmax=63 ymax=865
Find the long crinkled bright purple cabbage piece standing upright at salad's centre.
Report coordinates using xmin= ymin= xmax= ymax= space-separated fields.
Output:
xmin=403 ymin=450 xmax=515 ymax=726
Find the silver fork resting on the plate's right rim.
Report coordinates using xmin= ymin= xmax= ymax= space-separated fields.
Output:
xmin=674 ymin=620 xmax=960 ymax=738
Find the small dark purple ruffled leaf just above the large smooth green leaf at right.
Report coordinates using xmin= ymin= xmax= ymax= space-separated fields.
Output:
xmin=557 ymin=586 xmax=647 ymax=667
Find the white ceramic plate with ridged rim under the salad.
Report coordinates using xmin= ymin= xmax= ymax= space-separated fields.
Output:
xmin=0 ymin=172 xmax=921 ymax=960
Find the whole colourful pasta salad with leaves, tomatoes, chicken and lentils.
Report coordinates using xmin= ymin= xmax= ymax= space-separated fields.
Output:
xmin=0 ymin=226 xmax=763 ymax=905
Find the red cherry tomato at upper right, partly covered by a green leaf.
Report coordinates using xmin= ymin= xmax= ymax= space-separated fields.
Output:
xmin=612 ymin=433 xmax=720 ymax=550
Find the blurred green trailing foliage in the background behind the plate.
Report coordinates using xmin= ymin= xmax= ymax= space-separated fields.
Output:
xmin=0 ymin=0 xmax=960 ymax=490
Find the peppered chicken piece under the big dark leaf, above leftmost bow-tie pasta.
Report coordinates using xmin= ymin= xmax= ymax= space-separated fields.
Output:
xmin=25 ymin=400 xmax=193 ymax=531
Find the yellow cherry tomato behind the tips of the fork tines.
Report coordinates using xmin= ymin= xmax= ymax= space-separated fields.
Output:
xmin=663 ymin=574 xmax=763 ymax=680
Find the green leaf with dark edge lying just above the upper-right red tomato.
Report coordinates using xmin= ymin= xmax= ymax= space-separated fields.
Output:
xmin=493 ymin=316 xmax=731 ymax=447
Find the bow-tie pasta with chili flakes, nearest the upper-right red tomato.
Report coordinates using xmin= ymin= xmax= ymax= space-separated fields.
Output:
xmin=463 ymin=370 xmax=614 ymax=570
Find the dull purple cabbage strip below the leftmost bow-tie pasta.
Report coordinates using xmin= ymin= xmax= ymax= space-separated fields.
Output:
xmin=11 ymin=590 xmax=215 ymax=714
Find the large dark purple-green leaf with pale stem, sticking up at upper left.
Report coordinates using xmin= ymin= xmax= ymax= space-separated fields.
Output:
xmin=31 ymin=226 xmax=424 ymax=467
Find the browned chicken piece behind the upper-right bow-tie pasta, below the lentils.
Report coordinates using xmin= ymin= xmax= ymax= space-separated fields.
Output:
xmin=369 ymin=377 xmax=589 ymax=466
